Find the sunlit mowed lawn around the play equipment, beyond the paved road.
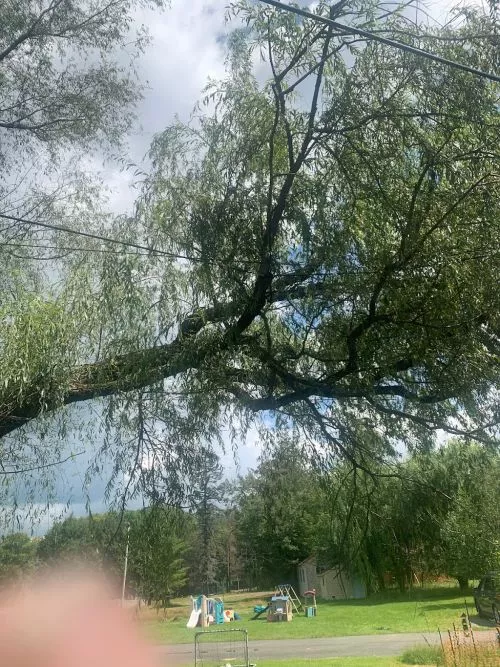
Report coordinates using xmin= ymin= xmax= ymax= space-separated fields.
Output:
xmin=141 ymin=588 xmax=479 ymax=644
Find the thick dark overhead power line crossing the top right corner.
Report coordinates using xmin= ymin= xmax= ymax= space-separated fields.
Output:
xmin=259 ymin=0 xmax=500 ymax=83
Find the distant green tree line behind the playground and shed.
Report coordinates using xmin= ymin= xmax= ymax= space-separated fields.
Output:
xmin=0 ymin=438 xmax=500 ymax=606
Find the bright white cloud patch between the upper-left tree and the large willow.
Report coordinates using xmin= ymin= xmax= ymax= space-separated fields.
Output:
xmin=100 ymin=0 xmax=226 ymax=213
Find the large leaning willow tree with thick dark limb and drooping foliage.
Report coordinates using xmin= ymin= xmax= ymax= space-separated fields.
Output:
xmin=0 ymin=0 xmax=500 ymax=506
